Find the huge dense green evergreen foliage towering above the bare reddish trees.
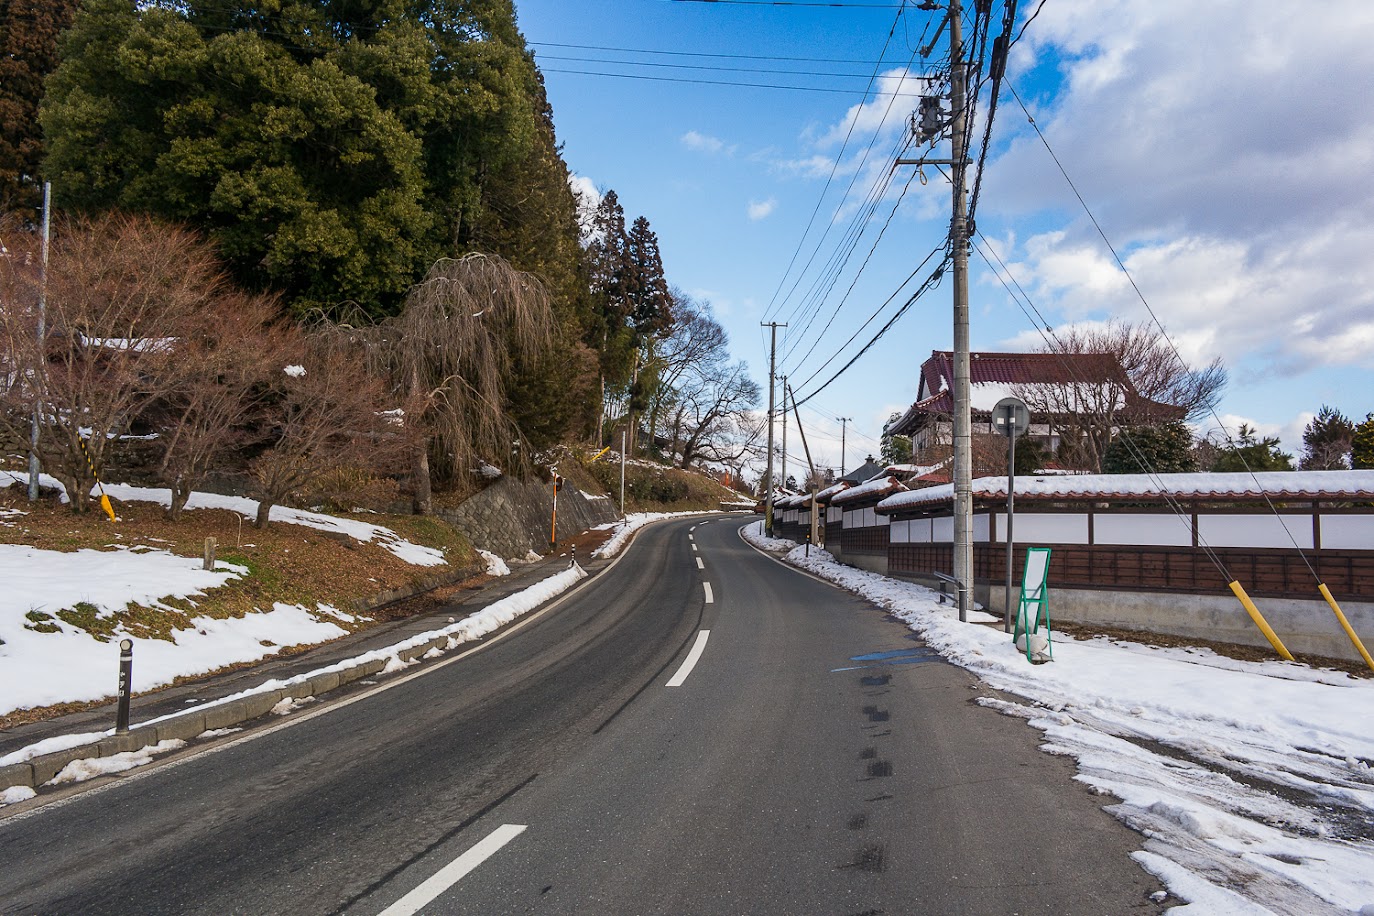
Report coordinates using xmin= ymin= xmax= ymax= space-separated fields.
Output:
xmin=43 ymin=0 xmax=587 ymax=325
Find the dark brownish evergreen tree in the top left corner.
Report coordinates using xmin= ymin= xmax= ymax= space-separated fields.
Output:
xmin=0 ymin=0 xmax=80 ymax=221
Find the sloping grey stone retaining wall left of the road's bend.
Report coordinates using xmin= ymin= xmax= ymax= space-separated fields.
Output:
xmin=436 ymin=477 xmax=620 ymax=559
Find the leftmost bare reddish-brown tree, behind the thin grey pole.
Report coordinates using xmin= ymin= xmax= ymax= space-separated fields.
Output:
xmin=0 ymin=214 xmax=224 ymax=512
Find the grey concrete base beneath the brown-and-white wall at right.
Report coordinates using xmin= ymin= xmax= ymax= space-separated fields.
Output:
xmin=974 ymin=582 xmax=1374 ymax=662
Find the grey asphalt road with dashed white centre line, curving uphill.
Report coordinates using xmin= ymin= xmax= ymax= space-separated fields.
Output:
xmin=0 ymin=519 xmax=1160 ymax=916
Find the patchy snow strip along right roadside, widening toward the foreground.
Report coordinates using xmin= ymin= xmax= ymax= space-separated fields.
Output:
xmin=745 ymin=523 xmax=1374 ymax=916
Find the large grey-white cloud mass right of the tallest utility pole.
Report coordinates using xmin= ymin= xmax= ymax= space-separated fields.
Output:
xmin=980 ymin=0 xmax=1374 ymax=376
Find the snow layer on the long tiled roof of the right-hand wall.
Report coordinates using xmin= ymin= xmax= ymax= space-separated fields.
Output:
xmin=878 ymin=471 xmax=1374 ymax=512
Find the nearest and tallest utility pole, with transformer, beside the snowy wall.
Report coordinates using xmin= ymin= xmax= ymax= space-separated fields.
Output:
xmin=897 ymin=0 xmax=973 ymax=622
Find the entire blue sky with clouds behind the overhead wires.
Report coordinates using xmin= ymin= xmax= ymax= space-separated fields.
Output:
xmin=517 ymin=0 xmax=1374 ymax=467
